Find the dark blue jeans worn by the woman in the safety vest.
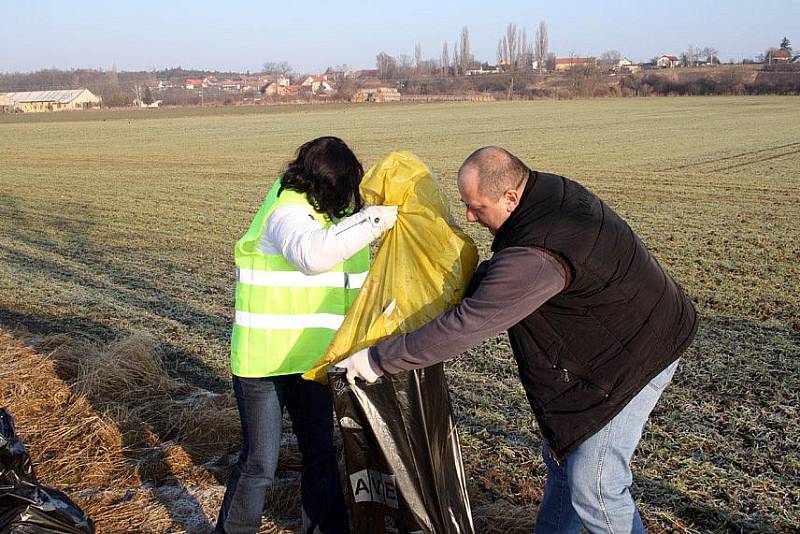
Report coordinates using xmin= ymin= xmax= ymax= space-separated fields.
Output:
xmin=216 ymin=375 xmax=350 ymax=534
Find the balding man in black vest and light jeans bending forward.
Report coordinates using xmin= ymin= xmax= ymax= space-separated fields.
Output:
xmin=338 ymin=147 xmax=697 ymax=533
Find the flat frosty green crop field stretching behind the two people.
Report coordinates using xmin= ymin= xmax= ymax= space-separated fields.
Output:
xmin=0 ymin=97 xmax=800 ymax=532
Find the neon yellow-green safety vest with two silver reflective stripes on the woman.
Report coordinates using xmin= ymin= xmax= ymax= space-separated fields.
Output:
xmin=231 ymin=179 xmax=369 ymax=378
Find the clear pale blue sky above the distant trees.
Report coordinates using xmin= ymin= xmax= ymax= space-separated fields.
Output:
xmin=0 ymin=0 xmax=800 ymax=72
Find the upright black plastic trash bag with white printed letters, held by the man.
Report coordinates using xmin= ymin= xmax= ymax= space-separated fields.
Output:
xmin=328 ymin=364 xmax=474 ymax=534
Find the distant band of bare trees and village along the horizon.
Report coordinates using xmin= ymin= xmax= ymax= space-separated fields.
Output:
xmin=0 ymin=33 xmax=800 ymax=107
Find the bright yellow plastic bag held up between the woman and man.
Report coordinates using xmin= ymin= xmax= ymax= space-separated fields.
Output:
xmin=303 ymin=151 xmax=478 ymax=383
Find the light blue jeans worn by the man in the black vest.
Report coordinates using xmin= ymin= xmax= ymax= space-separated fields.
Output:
xmin=534 ymin=361 xmax=678 ymax=534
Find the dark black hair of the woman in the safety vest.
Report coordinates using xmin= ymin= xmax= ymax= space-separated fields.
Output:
xmin=278 ymin=136 xmax=364 ymax=223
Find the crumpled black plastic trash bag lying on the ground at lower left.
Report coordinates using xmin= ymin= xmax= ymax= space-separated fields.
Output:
xmin=0 ymin=408 xmax=94 ymax=534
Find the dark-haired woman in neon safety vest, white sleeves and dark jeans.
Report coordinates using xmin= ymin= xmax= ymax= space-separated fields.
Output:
xmin=216 ymin=137 xmax=397 ymax=534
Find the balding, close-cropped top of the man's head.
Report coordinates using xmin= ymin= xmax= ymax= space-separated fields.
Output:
xmin=458 ymin=146 xmax=531 ymax=200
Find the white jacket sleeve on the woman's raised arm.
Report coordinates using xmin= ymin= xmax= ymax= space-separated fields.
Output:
xmin=259 ymin=206 xmax=384 ymax=274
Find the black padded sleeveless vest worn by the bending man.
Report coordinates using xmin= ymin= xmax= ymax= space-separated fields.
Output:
xmin=492 ymin=172 xmax=697 ymax=454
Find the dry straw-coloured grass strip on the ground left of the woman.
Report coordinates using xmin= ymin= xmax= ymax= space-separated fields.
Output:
xmin=0 ymin=330 xmax=298 ymax=533
